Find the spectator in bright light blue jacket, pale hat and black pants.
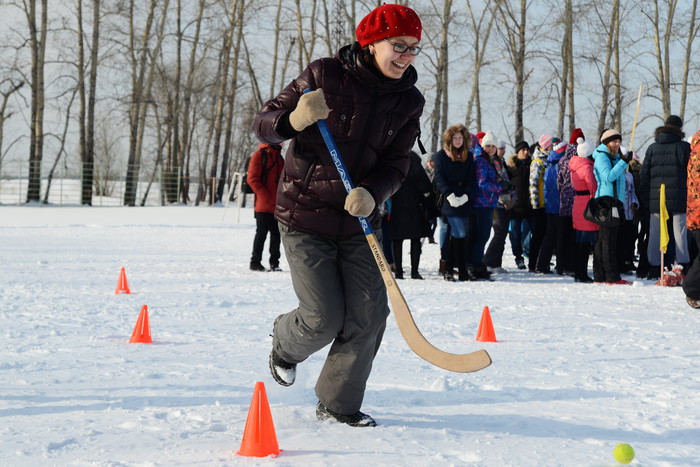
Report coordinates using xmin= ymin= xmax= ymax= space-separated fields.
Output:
xmin=593 ymin=130 xmax=631 ymax=285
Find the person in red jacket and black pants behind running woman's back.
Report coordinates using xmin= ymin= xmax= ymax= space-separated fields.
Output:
xmin=248 ymin=143 xmax=284 ymax=271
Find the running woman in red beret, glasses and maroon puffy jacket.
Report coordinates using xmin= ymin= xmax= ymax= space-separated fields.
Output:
xmin=254 ymin=5 xmax=425 ymax=426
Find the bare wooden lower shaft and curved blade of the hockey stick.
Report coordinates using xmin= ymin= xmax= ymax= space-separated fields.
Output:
xmin=365 ymin=233 xmax=491 ymax=373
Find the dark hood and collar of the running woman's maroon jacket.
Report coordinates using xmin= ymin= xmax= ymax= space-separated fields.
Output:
xmin=336 ymin=42 xmax=418 ymax=94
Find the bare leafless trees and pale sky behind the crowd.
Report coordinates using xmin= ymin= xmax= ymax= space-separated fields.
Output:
xmin=0 ymin=0 xmax=700 ymax=206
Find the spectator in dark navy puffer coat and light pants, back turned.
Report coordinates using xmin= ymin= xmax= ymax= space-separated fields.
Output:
xmin=639 ymin=115 xmax=690 ymax=280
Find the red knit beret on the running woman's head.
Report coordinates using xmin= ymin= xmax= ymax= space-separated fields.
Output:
xmin=355 ymin=4 xmax=423 ymax=47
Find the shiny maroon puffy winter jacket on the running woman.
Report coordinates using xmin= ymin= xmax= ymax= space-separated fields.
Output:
xmin=253 ymin=43 xmax=425 ymax=239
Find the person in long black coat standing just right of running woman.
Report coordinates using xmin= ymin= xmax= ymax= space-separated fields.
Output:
xmin=391 ymin=151 xmax=432 ymax=279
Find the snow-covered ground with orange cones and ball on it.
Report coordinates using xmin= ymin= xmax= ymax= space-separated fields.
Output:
xmin=0 ymin=206 xmax=700 ymax=466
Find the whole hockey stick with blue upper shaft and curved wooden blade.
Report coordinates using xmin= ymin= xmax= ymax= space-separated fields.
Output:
xmin=305 ymin=90 xmax=491 ymax=373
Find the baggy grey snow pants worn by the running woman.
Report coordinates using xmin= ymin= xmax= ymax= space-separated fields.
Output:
xmin=272 ymin=226 xmax=389 ymax=414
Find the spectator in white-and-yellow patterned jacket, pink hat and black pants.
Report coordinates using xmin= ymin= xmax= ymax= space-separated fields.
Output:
xmin=528 ymin=134 xmax=552 ymax=272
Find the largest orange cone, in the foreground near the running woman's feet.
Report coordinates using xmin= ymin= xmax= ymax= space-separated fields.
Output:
xmin=237 ymin=381 xmax=281 ymax=457
